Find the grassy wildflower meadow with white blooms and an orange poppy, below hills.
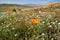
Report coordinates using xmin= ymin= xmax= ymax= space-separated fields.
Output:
xmin=0 ymin=3 xmax=60 ymax=40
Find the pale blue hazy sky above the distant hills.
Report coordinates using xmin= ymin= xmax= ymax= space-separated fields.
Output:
xmin=0 ymin=0 xmax=60 ymax=5
